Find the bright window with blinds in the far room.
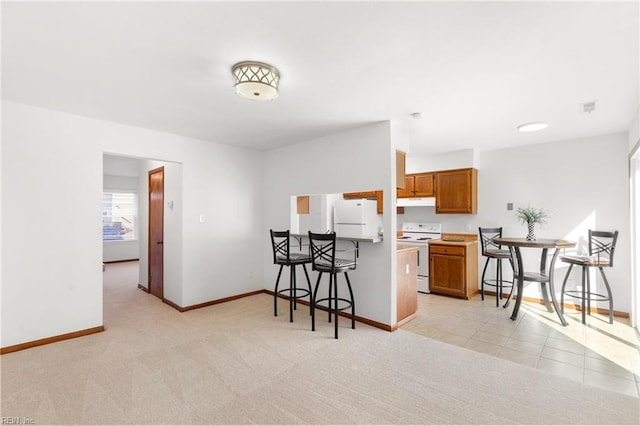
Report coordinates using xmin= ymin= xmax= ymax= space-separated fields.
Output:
xmin=102 ymin=192 xmax=138 ymax=241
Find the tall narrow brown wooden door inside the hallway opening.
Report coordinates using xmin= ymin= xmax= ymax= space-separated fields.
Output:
xmin=148 ymin=167 xmax=164 ymax=299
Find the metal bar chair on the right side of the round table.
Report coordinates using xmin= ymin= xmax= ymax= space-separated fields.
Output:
xmin=560 ymin=229 xmax=618 ymax=324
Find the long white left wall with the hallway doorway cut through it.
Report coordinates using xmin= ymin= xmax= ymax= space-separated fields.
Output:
xmin=0 ymin=101 xmax=266 ymax=347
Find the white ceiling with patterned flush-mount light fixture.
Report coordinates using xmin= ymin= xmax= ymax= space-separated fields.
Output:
xmin=2 ymin=1 xmax=640 ymax=155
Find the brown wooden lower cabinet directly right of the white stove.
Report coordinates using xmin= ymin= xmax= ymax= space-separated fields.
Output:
xmin=429 ymin=241 xmax=478 ymax=299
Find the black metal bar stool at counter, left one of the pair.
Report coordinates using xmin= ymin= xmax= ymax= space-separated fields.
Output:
xmin=270 ymin=229 xmax=311 ymax=322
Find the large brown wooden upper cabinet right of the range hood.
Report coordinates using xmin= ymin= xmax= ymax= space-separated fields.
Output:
xmin=434 ymin=168 xmax=478 ymax=214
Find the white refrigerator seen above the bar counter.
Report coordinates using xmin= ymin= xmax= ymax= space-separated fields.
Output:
xmin=333 ymin=199 xmax=380 ymax=237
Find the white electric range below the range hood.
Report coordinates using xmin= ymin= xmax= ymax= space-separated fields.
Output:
xmin=398 ymin=222 xmax=442 ymax=293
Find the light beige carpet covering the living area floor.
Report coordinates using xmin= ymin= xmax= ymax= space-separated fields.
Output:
xmin=1 ymin=264 xmax=640 ymax=424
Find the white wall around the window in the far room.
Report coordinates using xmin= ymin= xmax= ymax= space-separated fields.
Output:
xmin=102 ymin=171 xmax=140 ymax=262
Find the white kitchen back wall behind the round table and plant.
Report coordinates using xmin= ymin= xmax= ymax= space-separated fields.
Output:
xmin=398 ymin=133 xmax=631 ymax=312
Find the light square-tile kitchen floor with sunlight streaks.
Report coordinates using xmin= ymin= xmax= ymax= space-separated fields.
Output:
xmin=402 ymin=293 xmax=640 ymax=397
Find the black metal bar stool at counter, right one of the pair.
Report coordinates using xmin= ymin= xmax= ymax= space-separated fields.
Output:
xmin=309 ymin=232 xmax=356 ymax=339
